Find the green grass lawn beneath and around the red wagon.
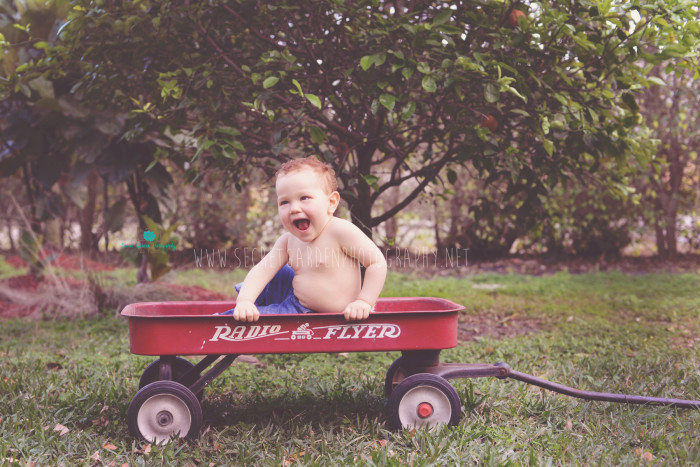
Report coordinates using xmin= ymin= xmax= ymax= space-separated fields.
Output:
xmin=0 ymin=270 xmax=700 ymax=466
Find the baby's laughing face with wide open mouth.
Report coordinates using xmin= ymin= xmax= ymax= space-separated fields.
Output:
xmin=275 ymin=169 xmax=339 ymax=242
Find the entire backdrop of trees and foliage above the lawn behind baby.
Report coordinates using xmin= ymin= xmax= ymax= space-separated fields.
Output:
xmin=0 ymin=0 xmax=700 ymax=281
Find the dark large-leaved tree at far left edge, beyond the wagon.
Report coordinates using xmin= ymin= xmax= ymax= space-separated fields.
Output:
xmin=0 ymin=1 xmax=178 ymax=281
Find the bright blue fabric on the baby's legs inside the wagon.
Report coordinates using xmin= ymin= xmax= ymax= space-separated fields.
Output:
xmin=219 ymin=264 xmax=311 ymax=315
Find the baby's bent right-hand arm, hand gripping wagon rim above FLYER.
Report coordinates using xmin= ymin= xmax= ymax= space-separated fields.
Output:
xmin=338 ymin=222 xmax=387 ymax=321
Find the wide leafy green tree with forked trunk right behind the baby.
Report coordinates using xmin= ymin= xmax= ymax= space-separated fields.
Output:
xmin=9 ymin=0 xmax=698 ymax=252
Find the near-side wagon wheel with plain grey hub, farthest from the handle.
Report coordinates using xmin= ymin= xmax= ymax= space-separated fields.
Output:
xmin=126 ymin=381 xmax=202 ymax=443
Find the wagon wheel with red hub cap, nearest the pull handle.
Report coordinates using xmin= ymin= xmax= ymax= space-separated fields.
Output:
xmin=387 ymin=373 xmax=462 ymax=429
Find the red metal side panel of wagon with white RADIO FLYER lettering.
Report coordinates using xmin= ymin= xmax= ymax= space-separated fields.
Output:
xmin=124 ymin=311 xmax=457 ymax=355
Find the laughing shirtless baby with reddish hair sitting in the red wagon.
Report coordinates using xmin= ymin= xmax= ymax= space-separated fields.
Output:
xmin=226 ymin=157 xmax=387 ymax=321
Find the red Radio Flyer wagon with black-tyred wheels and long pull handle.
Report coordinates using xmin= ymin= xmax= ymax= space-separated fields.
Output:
xmin=122 ymin=297 xmax=700 ymax=442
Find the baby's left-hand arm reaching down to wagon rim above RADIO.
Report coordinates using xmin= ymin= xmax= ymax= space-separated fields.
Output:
xmin=233 ymin=234 xmax=289 ymax=321
